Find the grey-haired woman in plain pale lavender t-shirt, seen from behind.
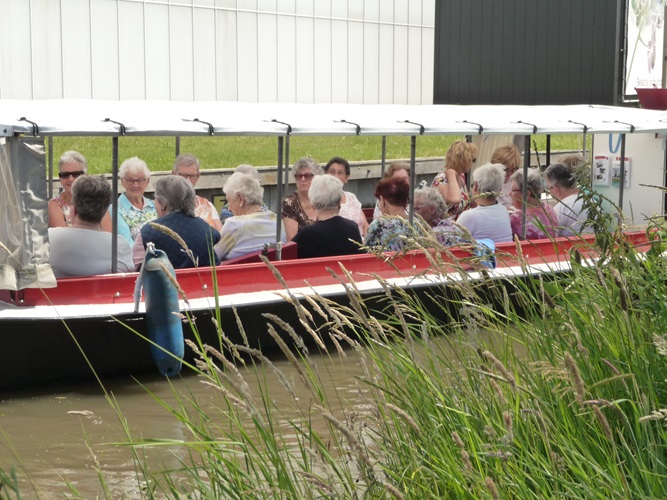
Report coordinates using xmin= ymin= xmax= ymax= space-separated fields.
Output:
xmin=458 ymin=163 xmax=512 ymax=244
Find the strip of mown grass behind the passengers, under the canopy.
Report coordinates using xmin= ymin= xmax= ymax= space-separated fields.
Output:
xmin=53 ymin=135 xmax=581 ymax=174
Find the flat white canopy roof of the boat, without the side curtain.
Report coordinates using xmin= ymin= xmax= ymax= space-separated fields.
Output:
xmin=0 ymin=100 xmax=667 ymax=136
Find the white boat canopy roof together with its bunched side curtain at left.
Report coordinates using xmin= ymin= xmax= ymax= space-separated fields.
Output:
xmin=0 ymin=100 xmax=667 ymax=290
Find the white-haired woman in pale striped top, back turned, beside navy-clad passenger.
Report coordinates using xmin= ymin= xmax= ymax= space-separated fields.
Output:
xmin=215 ymin=172 xmax=286 ymax=260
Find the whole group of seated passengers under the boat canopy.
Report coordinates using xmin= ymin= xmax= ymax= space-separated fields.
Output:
xmin=48 ymin=141 xmax=587 ymax=277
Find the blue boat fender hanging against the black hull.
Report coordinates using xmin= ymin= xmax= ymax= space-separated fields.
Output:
xmin=135 ymin=243 xmax=185 ymax=377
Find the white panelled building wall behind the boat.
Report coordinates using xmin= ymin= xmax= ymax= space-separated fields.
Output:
xmin=0 ymin=0 xmax=435 ymax=104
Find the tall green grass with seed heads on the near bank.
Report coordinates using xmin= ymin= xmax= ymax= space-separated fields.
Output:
xmin=5 ymin=207 xmax=667 ymax=499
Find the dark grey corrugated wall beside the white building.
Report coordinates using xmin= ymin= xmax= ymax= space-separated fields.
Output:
xmin=434 ymin=0 xmax=624 ymax=104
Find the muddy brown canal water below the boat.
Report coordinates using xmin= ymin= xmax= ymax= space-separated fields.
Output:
xmin=0 ymin=332 xmax=500 ymax=499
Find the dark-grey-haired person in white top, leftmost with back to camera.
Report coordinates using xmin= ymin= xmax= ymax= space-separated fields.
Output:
xmin=49 ymin=175 xmax=134 ymax=278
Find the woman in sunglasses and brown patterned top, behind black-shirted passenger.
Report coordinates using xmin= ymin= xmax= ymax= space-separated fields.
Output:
xmin=283 ymin=157 xmax=322 ymax=241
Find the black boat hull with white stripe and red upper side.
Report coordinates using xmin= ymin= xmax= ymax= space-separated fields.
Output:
xmin=0 ymin=233 xmax=647 ymax=391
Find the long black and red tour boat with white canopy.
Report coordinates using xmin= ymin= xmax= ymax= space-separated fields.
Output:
xmin=0 ymin=100 xmax=667 ymax=391
